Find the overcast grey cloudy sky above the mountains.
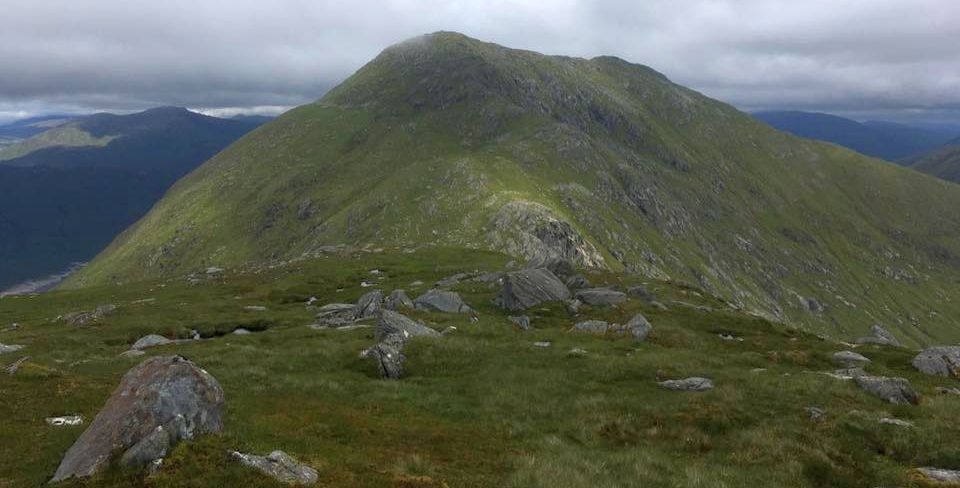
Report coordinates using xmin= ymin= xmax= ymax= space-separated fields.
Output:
xmin=0 ymin=0 xmax=960 ymax=126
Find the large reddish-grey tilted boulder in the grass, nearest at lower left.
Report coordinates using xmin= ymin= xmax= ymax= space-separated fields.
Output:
xmin=52 ymin=356 xmax=224 ymax=481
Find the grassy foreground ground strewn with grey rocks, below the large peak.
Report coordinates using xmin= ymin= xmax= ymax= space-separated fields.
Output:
xmin=0 ymin=249 xmax=960 ymax=488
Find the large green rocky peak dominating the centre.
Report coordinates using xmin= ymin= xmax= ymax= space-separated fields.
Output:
xmin=64 ymin=33 xmax=960 ymax=344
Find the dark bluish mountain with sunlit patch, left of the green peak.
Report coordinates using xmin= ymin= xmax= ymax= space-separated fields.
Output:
xmin=0 ymin=108 xmax=257 ymax=289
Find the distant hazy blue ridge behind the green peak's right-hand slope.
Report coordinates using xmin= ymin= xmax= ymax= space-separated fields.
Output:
xmin=753 ymin=111 xmax=956 ymax=161
